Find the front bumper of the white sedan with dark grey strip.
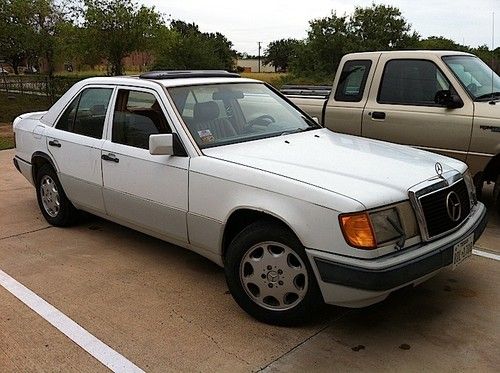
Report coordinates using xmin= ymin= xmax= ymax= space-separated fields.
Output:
xmin=307 ymin=203 xmax=487 ymax=307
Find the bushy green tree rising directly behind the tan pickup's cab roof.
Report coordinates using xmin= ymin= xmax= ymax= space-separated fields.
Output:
xmin=349 ymin=3 xmax=419 ymax=51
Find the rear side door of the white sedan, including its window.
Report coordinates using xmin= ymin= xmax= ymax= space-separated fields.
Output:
xmin=45 ymin=86 xmax=113 ymax=212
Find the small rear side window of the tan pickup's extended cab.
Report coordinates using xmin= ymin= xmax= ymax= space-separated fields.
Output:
xmin=335 ymin=60 xmax=372 ymax=102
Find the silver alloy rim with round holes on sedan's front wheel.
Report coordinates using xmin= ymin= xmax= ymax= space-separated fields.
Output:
xmin=240 ymin=241 xmax=308 ymax=310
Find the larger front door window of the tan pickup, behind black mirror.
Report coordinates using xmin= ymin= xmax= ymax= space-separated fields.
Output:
xmin=377 ymin=60 xmax=450 ymax=106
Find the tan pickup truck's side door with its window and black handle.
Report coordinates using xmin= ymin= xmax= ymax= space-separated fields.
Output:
xmin=362 ymin=55 xmax=473 ymax=161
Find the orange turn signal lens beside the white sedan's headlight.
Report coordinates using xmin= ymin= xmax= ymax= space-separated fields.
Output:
xmin=339 ymin=212 xmax=377 ymax=250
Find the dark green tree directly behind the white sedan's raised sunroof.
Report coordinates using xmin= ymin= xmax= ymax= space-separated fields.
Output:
xmin=154 ymin=20 xmax=236 ymax=70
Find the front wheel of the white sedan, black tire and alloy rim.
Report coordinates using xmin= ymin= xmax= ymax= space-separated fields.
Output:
xmin=225 ymin=221 xmax=324 ymax=326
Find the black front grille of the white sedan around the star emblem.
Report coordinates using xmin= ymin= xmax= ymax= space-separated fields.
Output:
xmin=419 ymin=179 xmax=470 ymax=238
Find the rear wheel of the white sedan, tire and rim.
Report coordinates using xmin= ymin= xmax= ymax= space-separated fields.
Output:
xmin=35 ymin=164 xmax=78 ymax=227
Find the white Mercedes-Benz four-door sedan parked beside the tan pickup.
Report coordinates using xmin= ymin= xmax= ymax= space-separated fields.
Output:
xmin=14 ymin=71 xmax=486 ymax=325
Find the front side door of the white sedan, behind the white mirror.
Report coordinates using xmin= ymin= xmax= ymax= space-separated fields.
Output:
xmin=102 ymin=88 xmax=189 ymax=242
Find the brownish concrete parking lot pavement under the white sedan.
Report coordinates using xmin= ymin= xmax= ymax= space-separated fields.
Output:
xmin=0 ymin=151 xmax=500 ymax=372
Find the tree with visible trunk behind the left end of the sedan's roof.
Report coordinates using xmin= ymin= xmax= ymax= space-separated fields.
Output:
xmin=82 ymin=0 xmax=163 ymax=75
